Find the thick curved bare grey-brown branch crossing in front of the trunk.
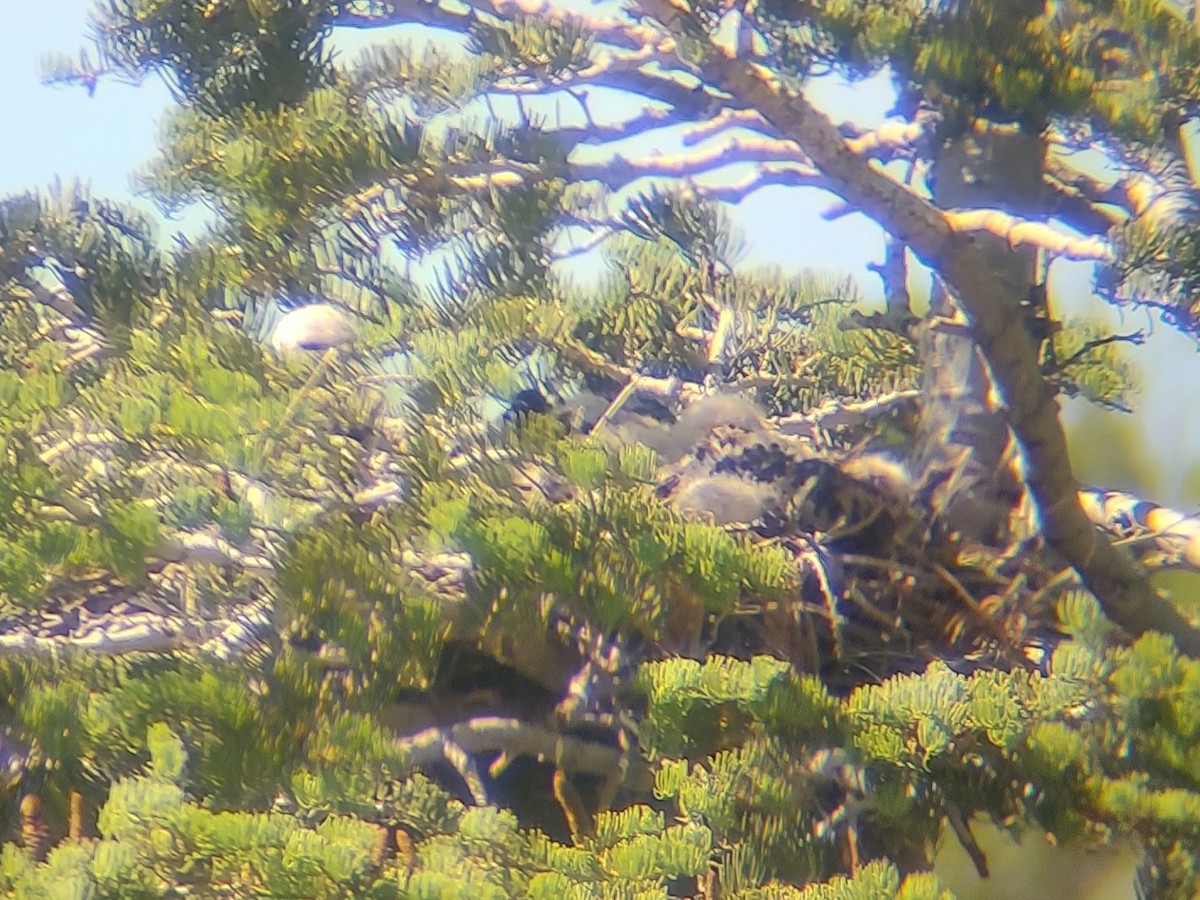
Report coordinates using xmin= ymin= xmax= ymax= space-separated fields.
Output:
xmin=638 ymin=0 xmax=1200 ymax=656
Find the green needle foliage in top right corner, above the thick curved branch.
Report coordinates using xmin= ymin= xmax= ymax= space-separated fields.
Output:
xmin=758 ymin=0 xmax=1200 ymax=136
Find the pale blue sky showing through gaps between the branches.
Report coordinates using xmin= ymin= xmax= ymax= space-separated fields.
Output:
xmin=0 ymin=0 xmax=1200 ymax=506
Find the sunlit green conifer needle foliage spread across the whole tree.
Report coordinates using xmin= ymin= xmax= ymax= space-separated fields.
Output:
xmin=7 ymin=0 xmax=1200 ymax=900
